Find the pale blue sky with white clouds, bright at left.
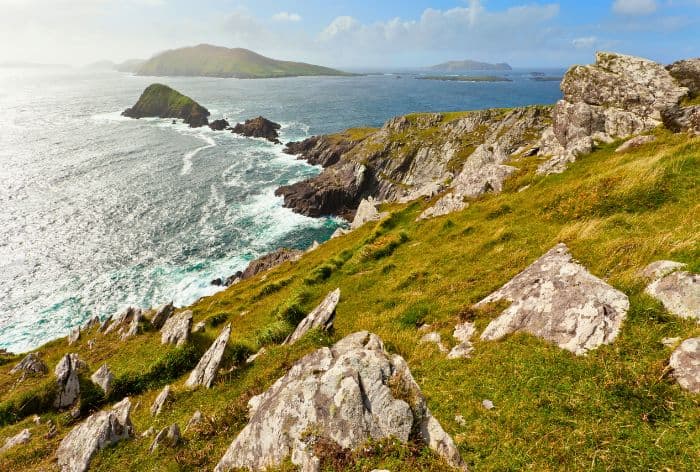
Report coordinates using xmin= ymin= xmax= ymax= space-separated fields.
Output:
xmin=0 ymin=0 xmax=700 ymax=69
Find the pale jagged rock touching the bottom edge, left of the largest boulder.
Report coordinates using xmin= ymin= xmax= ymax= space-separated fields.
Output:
xmin=56 ymin=398 xmax=134 ymax=472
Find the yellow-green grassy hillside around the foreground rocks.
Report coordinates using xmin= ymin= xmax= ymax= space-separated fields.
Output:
xmin=0 ymin=125 xmax=700 ymax=472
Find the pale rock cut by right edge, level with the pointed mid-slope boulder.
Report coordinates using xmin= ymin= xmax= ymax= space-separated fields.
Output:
xmin=642 ymin=261 xmax=700 ymax=323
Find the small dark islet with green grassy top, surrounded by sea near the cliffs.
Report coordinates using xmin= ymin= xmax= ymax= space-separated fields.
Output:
xmin=122 ymin=84 xmax=210 ymax=128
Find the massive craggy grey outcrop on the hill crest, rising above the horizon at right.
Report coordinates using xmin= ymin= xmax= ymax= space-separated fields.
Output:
xmin=539 ymin=52 xmax=688 ymax=174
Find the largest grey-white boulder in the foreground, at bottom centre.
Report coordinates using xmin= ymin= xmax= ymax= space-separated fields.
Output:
xmin=214 ymin=331 xmax=466 ymax=472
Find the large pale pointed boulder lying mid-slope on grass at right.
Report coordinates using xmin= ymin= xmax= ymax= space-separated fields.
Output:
xmin=476 ymin=244 xmax=629 ymax=355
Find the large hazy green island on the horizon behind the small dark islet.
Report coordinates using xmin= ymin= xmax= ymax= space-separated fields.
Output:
xmin=136 ymin=44 xmax=350 ymax=79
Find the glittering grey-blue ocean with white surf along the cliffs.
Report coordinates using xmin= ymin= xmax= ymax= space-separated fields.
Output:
xmin=0 ymin=68 xmax=563 ymax=352
